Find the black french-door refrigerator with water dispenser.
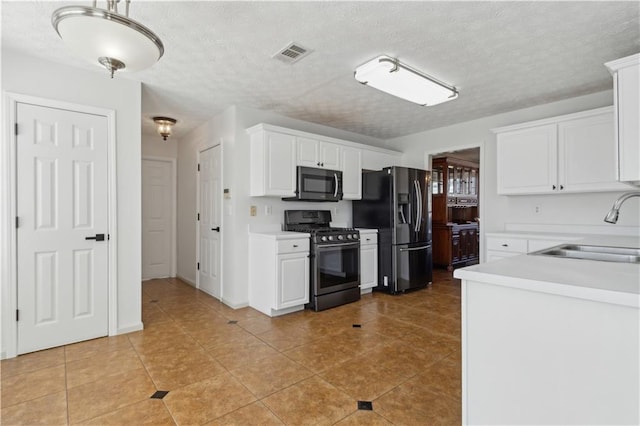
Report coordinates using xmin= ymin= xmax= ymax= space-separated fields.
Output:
xmin=352 ymin=167 xmax=433 ymax=294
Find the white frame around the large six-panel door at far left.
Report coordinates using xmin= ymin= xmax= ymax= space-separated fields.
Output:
xmin=0 ymin=92 xmax=118 ymax=358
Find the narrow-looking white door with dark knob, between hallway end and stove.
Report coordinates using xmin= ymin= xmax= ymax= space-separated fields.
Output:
xmin=198 ymin=145 xmax=222 ymax=299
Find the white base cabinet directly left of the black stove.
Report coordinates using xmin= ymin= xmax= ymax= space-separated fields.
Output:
xmin=249 ymin=232 xmax=309 ymax=317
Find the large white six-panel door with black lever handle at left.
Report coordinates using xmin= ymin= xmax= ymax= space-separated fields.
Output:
xmin=16 ymin=103 xmax=109 ymax=354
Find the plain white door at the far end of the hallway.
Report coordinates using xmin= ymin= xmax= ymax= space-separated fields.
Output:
xmin=142 ymin=159 xmax=174 ymax=279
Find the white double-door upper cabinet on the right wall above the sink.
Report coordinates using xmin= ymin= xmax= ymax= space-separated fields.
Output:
xmin=494 ymin=107 xmax=627 ymax=195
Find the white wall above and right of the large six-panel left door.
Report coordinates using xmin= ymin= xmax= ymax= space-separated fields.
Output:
xmin=2 ymin=49 xmax=142 ymax=347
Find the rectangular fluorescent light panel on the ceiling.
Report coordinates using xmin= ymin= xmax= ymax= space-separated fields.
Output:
xmin=355 ymin=55 xmax=458 ymax=106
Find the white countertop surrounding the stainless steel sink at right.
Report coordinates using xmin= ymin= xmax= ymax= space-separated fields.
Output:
xmin=454 ymin=232 xmax=640 ymax=308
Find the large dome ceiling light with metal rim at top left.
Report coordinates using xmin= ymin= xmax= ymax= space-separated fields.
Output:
xmin=51 ymin=0 xmax=164 ymax=78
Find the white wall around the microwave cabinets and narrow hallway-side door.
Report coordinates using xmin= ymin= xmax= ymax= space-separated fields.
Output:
xmin=178 ymin=107 xmax=401 ymax=307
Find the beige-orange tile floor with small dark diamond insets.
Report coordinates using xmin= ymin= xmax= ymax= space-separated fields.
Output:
xmin=0 ymin=271 xmax=461 ymax=425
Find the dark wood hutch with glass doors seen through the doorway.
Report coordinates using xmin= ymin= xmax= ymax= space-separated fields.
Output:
xmin=431 ymin=157 xmax=480 ymax=270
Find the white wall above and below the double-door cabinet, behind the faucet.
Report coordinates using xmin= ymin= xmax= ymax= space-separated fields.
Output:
xmin=387 ymin=91 xmax=640 ymax=240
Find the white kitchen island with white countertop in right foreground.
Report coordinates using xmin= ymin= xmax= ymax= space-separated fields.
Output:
xmin=454 ymin=234 xmax=640 ymax=424
